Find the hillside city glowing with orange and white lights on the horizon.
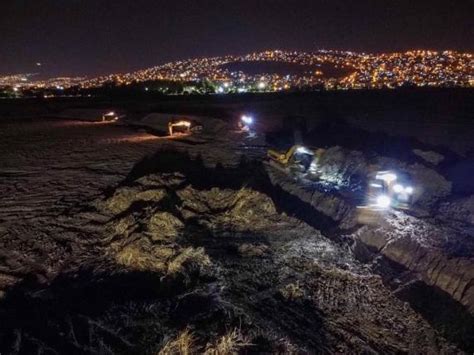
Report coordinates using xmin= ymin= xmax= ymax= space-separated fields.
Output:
xmin=0 ymin=50 xmax=474 ymax=94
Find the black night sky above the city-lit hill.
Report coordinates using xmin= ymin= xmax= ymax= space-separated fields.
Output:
xmin=0 ymin=0 xmax=474 ymax=75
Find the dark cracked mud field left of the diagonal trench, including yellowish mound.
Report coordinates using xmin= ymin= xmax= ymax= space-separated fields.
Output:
xmin=0 ymin=116 xmax=472 ymax=354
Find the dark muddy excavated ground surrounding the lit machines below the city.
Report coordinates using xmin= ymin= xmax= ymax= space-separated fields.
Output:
xmin=0 ymin=93 xmax=474 ymax=354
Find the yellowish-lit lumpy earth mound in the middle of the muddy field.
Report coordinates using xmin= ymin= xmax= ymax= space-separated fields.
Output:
xmin=95 ymin=174 xmax=282 ymax=288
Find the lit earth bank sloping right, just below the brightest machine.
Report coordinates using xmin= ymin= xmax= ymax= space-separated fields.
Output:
xmin=352 ymin=213 xmax=474 ymax=314
